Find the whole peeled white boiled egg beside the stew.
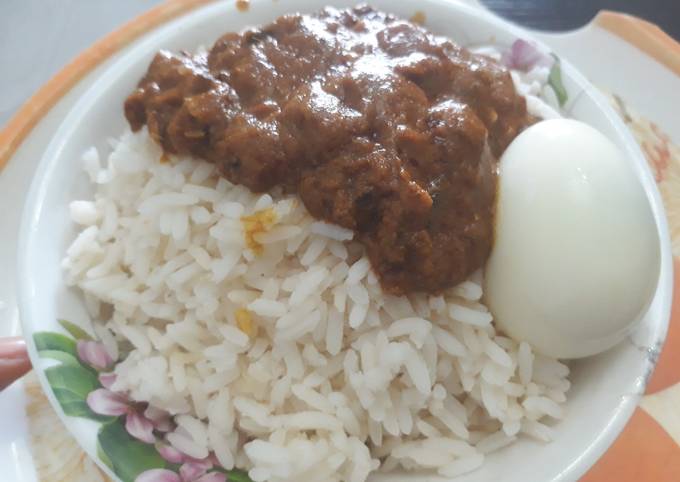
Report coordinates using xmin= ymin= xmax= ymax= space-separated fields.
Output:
xmin=485 ymin=119 xmax=660 ymax=358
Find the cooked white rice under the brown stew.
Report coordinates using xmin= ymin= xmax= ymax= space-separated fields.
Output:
xmin=64 ymin=51 xmax=569 ymax=482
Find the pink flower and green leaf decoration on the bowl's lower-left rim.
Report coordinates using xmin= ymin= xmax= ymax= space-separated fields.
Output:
xmin=33 ymin=320 xmax=250 ymax=482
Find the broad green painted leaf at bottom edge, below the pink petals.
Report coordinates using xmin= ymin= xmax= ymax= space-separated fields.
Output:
xmin=98 ymin=420 xmax=166 ymax=482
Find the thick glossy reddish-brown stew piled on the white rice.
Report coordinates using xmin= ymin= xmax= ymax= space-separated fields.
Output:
xmin=125 ymin=6 xmax=530 ymax=294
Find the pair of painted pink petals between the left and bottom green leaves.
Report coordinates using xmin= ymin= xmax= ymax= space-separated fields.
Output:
xmin=87 ymin=388 xmax=162 ymax=444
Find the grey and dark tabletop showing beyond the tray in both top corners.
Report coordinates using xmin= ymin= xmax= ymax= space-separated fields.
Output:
xmin=0 ymin=0 xmax=680 ymax=125
